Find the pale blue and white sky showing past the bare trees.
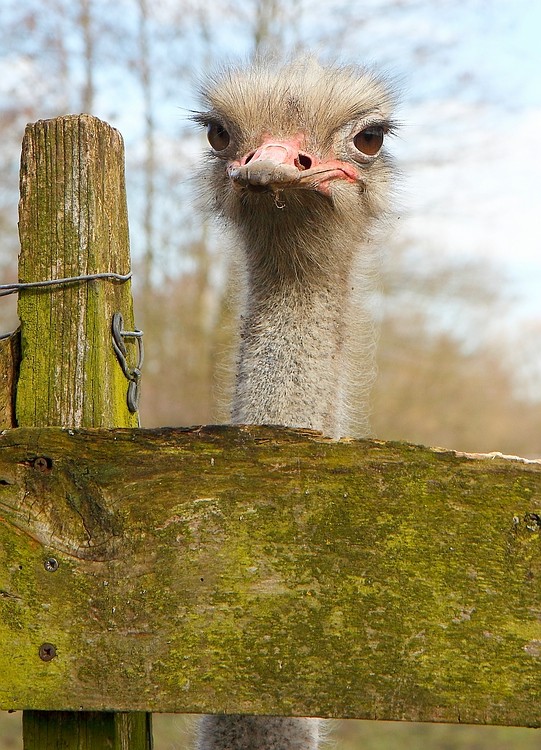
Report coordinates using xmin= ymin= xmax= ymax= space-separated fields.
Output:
xmin=0 ymin=0 xmax=541 ymax=328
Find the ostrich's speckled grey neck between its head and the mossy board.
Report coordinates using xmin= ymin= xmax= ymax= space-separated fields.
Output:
xmin=232 ymin=244 xmax=351 ymax=438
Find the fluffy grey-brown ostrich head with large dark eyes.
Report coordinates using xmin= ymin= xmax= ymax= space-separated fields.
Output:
xmin=195 ymin=58 xmax=393 ymax=282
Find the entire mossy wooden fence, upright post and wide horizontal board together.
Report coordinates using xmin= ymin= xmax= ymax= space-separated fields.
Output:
xmin=0 ymin=116 xmax=541 ymax=750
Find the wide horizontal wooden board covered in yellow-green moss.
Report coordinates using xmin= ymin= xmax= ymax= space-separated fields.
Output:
xmin=0 ymin=427 xmax=541 ymax=726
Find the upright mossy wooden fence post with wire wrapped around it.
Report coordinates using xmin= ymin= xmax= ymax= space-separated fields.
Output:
xmin=16 ymin=115 xmax=152 ymax=750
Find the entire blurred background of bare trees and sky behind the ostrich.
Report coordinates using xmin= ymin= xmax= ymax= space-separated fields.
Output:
xmin=0 ymin=0 xmax=541 ymax=750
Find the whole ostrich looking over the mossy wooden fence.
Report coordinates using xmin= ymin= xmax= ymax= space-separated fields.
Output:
xmin=195 ymin=58 xmax=393 ymax=750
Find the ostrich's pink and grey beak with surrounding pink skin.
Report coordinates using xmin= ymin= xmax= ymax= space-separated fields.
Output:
xmin=227 ymin=133 xmax=360 ymax=195
